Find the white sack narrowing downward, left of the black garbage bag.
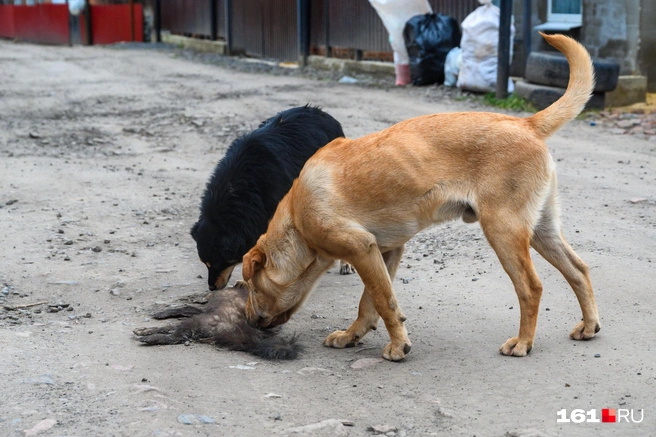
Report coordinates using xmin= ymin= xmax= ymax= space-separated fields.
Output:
xmin=369 ymin=0 xmax=433 ymax=64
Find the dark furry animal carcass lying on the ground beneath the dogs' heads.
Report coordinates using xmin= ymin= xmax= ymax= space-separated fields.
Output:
xmin=134 ymin=281 xmax=300 ymax=360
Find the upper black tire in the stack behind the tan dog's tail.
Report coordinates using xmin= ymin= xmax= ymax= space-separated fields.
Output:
xmin=526 ymin=52 xmax=620 ymax=93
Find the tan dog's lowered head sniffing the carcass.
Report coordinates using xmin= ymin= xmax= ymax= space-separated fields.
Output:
xmin=242 ymin=218 xmax=332 ymax=328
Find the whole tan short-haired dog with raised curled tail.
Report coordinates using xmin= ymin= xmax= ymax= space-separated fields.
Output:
xmin=243 ymin=35 xmax=600 ymax=361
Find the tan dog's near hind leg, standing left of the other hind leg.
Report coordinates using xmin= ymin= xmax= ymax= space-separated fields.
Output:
xmin=481 ymin=213 xmax=542 ymax=357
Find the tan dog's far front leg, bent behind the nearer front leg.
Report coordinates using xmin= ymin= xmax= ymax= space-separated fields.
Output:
xmin=323 ymin=246 xmax=404 ymax=349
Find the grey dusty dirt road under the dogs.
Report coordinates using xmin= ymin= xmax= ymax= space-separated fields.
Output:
xmin=0 ymin=41 xmax=656 ymax=437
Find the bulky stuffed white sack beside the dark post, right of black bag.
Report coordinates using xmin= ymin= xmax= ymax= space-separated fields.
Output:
xmin=457 ymin=0 xmax=515 ymax=92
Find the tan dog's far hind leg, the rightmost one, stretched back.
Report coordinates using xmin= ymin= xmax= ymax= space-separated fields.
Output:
xmin=531 ymin=202 xmax=601 ymax=340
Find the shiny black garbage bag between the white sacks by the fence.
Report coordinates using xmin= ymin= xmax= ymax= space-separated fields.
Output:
xmin=403 ymin=14 xmax=462 ymax=85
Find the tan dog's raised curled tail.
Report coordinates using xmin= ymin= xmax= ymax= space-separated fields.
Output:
xmin=528 ymin=32 xmax=595 ymax=139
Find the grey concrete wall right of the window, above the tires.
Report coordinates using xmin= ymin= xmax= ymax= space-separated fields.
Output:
xmin=581 ymin=0 xmax=640 ymax=75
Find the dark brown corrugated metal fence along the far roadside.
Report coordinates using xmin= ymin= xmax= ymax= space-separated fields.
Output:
xmin=156 ymin=0 xmax=478 ymax=61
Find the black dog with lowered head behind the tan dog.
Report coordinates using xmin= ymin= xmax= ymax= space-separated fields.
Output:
xmin=191 ymin=106 xmax=352 ymax=290
